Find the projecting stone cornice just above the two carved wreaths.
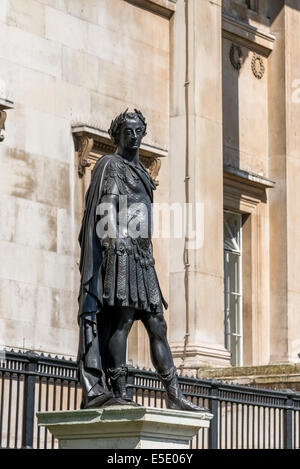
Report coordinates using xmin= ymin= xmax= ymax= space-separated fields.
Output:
xmin=222 ymin=13 xmax=276 ymax=57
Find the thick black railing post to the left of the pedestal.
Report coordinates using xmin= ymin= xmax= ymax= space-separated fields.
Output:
xmin=22 ymin=352 xmax=38 ymax=449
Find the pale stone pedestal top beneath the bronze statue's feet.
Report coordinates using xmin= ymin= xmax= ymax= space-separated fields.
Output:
xmin=37 ymin=406 xmax=213 ymax=449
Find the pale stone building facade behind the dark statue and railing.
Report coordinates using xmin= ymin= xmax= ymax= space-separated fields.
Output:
xmin=0 ymin=0 xmax=300 ymax=381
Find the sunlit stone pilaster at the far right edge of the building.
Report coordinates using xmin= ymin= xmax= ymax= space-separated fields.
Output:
xmin=269 ymin=0 xmax=300 ymax=363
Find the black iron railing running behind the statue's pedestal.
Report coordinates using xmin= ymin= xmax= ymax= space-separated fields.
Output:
xmin=0 ymin=351 xmax=300 ymax=449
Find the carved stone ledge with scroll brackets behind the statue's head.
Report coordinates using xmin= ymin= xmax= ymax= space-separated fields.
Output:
xmin=72 ymin=124 xmax=168 ymax=186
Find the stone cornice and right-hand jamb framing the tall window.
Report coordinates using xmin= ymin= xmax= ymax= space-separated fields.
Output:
xmin=223 ymin=165 xmax=275 ymax=365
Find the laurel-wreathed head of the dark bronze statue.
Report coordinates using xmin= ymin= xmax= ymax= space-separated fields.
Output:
xmin=108 ymin=109 xmax=147 ymax=150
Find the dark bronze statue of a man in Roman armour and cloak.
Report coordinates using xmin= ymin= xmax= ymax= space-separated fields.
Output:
xmin=78 ymin=110 xmax=202 ymax=411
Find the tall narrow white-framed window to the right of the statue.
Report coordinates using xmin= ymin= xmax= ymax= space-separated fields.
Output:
xmin=224 ymin=211 xmax=243 ymax=366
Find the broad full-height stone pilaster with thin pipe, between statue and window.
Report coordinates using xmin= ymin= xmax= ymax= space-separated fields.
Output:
xmin=169 ymin=0 xmax=230 ymax=372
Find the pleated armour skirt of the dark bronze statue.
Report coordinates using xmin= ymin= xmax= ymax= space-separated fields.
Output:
xmin=102 ymin=238 xmax=168 ymax=313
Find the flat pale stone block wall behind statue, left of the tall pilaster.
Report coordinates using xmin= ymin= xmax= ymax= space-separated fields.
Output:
xmin=0 ymin=0 xmax=169 ymax=356
